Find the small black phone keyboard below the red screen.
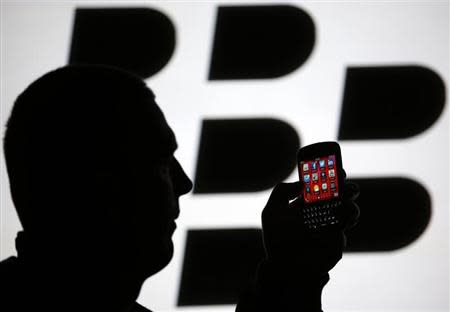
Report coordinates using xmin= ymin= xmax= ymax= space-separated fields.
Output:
xmin=303 ymin=200 xmax=341 ymax=229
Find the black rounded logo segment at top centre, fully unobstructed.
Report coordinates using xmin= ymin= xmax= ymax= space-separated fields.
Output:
xmin=209 ymin=5 xmax=316 ymax=80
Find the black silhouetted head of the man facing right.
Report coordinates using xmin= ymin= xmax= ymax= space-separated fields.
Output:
xmin=4 ymin=66 xmax=192 ymax=275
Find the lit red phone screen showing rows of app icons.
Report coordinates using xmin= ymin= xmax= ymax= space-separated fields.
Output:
xmin=299 ymin=155 xmax=339 ymax=203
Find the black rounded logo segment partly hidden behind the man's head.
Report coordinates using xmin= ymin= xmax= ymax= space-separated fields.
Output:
xmin=69 ymin=8 xmax=176 ymax=78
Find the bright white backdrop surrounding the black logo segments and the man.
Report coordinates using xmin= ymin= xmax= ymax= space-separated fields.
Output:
xmin=0 ymin=1 xmax=450 ymax=311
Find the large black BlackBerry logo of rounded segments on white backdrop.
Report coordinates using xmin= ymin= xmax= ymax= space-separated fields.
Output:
xmin=69 ymin=5 xmax=446 ymax=305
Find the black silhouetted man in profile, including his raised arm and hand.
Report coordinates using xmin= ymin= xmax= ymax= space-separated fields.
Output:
xmin=1 ymin=66 xmax=353 ymax=311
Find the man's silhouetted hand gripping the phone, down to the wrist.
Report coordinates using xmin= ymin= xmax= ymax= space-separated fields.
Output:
xmin=262 ymin=182 xmax=359 ymax=278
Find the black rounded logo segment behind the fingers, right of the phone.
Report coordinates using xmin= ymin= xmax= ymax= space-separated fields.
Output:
xmin=345 ymin=177 xmax=432 ymax=252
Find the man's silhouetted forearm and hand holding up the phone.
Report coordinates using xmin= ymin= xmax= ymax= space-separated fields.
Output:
xmin=236 ymin=182 xmax=359 ymax=312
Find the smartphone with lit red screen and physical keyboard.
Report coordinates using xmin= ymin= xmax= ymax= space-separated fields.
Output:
xmin=297 ymin=142 xmax=344 ymax=230
